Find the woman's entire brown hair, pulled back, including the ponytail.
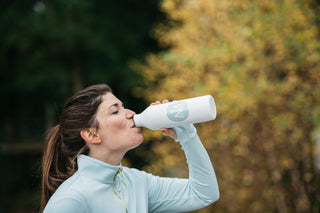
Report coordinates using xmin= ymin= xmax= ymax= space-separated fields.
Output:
xmin=40 ymin=84 xmax=112 ymax=212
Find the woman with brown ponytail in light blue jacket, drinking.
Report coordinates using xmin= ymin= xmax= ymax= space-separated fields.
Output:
xmin=41 ymin=84 xmax=219 ymax=213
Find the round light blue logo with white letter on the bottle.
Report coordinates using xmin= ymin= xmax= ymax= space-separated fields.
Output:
xmin=167 ymin=101 xmax=189 ymax=122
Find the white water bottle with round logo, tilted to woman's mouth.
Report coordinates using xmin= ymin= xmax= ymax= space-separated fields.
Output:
xmin=133 ymin=95 xmax=217 ymax=130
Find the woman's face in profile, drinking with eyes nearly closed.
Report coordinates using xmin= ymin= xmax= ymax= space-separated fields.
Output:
xmin=96 ymin=92 xmax=143 ymax=153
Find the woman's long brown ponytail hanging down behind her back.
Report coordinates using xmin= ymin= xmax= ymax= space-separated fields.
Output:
xmin=40 ymin=125 xmax=70 ymax=212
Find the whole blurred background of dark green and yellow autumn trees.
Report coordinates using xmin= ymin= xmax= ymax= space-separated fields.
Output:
xmin=0 ymin=0 xmax=320 ymax=213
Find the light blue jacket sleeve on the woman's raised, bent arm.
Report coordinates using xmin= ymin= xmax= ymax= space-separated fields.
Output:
xmin=147 ymin=125 xmax=220 ymax=212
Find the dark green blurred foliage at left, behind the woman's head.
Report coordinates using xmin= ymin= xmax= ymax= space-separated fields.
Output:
xmin=0 ymin=0 xmax=161 ymax=212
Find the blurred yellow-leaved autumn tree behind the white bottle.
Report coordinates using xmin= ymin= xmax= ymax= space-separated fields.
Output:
xmin=133 ymin=0 xmax=320 ymax=213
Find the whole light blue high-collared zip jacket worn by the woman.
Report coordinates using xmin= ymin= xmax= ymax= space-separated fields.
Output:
xmin=44 ymin=125 xmax=219 ymax=213
